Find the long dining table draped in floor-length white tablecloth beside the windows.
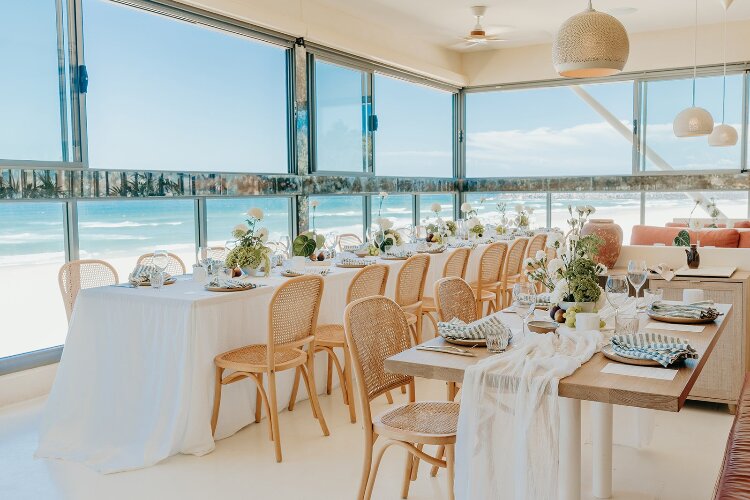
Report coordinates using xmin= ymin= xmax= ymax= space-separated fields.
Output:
xmin=36 ymin=245 xmax=506 ymax=473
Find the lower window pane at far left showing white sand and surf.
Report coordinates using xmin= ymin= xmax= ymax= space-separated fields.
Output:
xmin=0 ymin=202 xmax=67 ymax=358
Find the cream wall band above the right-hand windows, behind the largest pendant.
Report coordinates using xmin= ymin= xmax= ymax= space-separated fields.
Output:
xmin=463 ymin=21 xmax=750 ymax=86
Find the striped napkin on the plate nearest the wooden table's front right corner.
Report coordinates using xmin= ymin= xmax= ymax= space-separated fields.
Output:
xmin=611 ymin=333 xmax=698 ymax=368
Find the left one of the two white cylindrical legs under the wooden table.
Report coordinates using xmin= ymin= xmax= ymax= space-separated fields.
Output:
xmin=559 ymin=397 xmax=581 ymax=500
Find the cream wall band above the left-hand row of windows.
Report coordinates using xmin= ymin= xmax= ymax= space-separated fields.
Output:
xmin=181 ymin=0 xmax=466 ymax=86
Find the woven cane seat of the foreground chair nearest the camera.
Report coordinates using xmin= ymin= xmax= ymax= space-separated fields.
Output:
xmin=374 ymin=401 xmax=460 ymax=442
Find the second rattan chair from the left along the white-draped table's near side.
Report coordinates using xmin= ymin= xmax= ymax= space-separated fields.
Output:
xmin=289 ymin=264 xmax=393 ymax=423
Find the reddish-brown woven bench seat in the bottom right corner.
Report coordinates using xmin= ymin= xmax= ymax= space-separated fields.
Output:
xmin=714 ymin=375 xmax=750 ymax=500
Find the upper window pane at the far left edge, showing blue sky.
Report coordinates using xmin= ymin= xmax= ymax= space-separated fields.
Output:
xmin=0 ymin=0 xmax=68 ymax=161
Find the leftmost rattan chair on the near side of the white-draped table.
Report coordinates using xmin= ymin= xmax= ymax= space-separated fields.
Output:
xmin=211 ymin=276 xmax=329 ymax=462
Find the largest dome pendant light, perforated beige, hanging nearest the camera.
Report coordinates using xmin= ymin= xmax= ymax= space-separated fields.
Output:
xmin=552 ymin=0 xmax=630 ymax=78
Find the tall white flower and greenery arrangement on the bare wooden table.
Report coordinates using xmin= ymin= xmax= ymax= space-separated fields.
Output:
xmin=524 ymin=206 xmax=607 ymax=312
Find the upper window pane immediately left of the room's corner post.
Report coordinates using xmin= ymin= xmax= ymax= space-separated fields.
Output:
xmin=373 ymin=74 xmax=453 ymax=177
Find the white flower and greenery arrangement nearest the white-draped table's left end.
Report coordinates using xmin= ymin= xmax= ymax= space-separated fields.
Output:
xmin=226 ymin=208 xmax=271 ymax=276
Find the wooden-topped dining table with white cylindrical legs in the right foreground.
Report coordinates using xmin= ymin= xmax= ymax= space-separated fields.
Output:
xmin=385 ymin=304 xmax=732 ymax=500
